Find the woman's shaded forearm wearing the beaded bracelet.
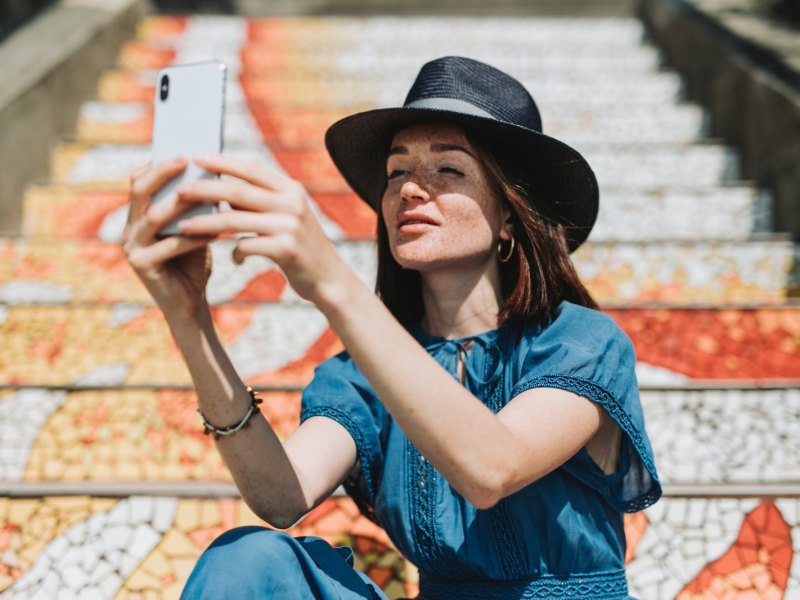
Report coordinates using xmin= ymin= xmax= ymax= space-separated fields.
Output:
xmin=168 ymin=310 xmax=310 ymax=527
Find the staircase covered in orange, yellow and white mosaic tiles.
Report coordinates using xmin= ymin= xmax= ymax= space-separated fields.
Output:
xmin=0 ymin=17 xmax=800 ymax=600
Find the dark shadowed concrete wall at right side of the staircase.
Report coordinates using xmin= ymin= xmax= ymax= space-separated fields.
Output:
xmin=639 ymin=0 xmax=800 ymax=240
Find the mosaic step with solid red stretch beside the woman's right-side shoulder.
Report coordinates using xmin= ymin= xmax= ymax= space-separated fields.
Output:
xmin=0 ymin=303 xmax=800 ymax=387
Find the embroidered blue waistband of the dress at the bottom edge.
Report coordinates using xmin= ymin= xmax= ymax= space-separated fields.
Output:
xmin=419 ymin=570 xmax=628 ymax=600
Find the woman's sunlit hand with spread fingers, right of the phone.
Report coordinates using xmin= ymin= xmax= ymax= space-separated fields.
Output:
xmin=178 ymin=155 xmax=349 ymax=303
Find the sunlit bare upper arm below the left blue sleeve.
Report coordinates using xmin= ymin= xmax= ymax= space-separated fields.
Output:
xmin=283 ymin=416 xmax=358 ymax=510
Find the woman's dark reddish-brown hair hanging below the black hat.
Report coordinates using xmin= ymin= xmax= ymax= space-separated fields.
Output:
xmin=375 ymin=131 xmax=597 ymax=326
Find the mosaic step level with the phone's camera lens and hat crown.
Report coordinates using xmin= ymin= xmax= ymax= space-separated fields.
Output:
xmin=98 ymin=64 xmax=683 ymax=109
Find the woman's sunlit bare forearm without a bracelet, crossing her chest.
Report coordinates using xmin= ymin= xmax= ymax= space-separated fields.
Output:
xmin=318 ymin=281 xmax=527 ymax=505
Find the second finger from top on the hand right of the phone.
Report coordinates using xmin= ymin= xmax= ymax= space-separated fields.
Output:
xmin=176 ymin=179 xmax=297 ymax=212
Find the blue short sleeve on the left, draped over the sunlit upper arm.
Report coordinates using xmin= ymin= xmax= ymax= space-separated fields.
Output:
xmin=300 ymin=352 xmax=389 ymax=517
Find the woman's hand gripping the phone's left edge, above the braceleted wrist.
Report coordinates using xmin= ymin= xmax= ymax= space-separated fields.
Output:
xmin=122 ymin=158 xmax=214 ymax=320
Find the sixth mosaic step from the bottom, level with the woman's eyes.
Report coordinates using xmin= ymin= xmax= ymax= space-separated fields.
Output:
xmin=51 ymin=142 xmax=738 ymax=194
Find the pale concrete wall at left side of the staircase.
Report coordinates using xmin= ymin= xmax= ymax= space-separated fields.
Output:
xmin=0 ymin=0 xmax=147 ymax=234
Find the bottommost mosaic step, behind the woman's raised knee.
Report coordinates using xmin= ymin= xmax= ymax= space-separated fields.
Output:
xmin=0 ymin=495 xmax=800 ymax=599
